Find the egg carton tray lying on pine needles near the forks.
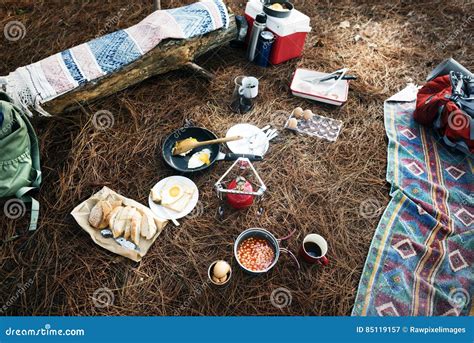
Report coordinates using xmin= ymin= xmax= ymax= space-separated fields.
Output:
xmin=285 ymin=114 xmax=343 ymax=142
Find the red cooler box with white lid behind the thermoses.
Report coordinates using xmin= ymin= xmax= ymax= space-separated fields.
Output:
xmin=245 ymin=0 xmax=311 ymax=64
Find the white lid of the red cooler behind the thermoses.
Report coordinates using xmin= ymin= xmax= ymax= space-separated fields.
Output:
xmin=245 ymin=0 xmax=311 ymax=37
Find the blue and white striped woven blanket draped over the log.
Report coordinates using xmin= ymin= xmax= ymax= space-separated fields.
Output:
xmin=0 ymin=0 xmax=229 ymax=115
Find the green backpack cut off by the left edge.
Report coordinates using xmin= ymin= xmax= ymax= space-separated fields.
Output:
xmin=0 ymin=92 xmax=41 ymax=235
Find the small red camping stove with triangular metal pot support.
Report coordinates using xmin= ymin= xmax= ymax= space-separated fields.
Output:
xmin=214 ymin=157 xmax=267 ymax=217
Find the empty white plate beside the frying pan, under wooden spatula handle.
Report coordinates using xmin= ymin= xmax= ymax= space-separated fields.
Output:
xmin=225 ymin=124 xmax=269 ymax=156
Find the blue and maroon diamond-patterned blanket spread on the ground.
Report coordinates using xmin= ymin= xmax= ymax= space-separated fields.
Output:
xmin=352 ymin=87 xmax=474 ymax=316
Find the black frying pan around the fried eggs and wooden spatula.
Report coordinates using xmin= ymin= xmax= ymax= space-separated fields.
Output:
xmin=161 ymin=127 xmax=262 ymax=173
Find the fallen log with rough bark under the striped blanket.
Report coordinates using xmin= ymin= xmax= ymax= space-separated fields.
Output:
xmin=42 ymin=14 xmax=237 ymax=115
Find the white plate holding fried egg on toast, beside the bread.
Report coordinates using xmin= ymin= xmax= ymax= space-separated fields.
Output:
xmin=148 ymin=176 xmax=199 ymax=219
